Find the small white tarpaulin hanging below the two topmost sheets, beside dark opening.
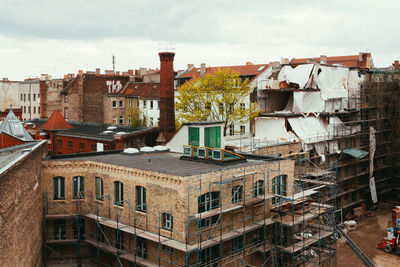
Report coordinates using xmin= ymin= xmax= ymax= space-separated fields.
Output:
xmin=291 ymin=92 xmax=325 ymax=113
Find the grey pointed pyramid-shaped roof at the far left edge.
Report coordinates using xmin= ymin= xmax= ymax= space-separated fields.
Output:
xmin=0 ymin=109 xmax=33 ymax=141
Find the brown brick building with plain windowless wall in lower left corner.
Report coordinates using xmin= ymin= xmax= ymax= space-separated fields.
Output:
xmin=0 ymin=141 xmax=47 ymax=266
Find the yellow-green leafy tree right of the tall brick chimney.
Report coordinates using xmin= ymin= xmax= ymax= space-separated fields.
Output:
xmin=175 ymin=69 xmax=258 ymax=135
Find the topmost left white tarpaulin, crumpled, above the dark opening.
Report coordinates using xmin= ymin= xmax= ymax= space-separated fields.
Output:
xmin=278 ymin=64 xmax=314 ymax=89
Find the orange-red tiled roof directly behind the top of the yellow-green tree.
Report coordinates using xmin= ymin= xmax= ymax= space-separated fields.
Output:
xmin=179 ymin=64 xmax=269 ymax=82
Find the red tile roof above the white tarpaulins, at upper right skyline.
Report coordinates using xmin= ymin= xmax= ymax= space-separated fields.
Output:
xmin=290 ymin=53 xmax=372 ymax=68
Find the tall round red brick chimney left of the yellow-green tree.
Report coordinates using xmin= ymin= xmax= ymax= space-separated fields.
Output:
xmin=156 ymin=52 xmax=175 ymax=145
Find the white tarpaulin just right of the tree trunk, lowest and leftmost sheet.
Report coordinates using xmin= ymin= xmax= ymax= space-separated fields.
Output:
xmin=254 ymin=117 xmax=298 ymax=142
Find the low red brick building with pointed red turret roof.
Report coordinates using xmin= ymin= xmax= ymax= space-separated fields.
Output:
xmin=27 ymin=111 xmax=158 ymax=155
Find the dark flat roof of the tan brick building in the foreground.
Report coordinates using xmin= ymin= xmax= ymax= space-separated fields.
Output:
xmin=48 ymin=152 xmax=266 ymax=176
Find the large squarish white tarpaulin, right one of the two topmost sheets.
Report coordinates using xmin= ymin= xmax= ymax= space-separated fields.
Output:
xmin=313 ymin=64 xmax=349 ymax=100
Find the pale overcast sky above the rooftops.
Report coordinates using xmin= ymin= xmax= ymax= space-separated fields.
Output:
xmin=0 ymin=0 xmax=400 ymax=80
